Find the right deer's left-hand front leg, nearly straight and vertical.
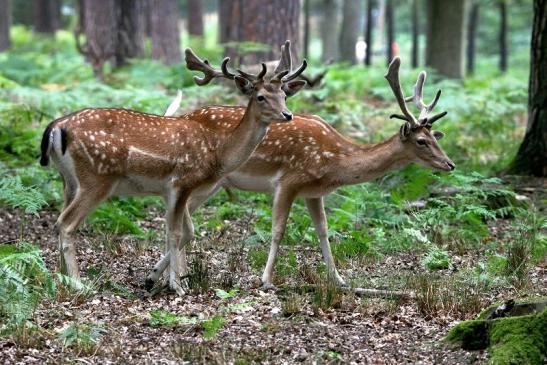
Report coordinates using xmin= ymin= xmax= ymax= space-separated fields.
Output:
xmin=262 ymin=189 xmax=296 ymax=289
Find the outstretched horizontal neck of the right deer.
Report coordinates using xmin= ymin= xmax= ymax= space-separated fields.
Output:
xmin=339 ymin=134 xmax=411 ymax=185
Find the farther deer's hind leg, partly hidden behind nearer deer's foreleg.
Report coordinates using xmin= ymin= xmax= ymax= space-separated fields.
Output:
xmin=144 ymin=183 xmax=222 ymax=290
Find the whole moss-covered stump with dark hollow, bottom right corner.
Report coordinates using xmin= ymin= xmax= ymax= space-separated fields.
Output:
xmin=445 ymin=310 xmax=547 ymax=364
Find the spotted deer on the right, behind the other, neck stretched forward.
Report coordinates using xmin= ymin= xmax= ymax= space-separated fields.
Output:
xmin=144 ymin=57 xmax=455 ymax=289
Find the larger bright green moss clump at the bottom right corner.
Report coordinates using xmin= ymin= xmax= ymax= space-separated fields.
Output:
xmin=490 ymin=310 xmax=547 ymax=364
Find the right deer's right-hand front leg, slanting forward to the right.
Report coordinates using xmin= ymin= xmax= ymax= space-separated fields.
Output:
xmin=306 ymin=197 xmax=347 ymax=287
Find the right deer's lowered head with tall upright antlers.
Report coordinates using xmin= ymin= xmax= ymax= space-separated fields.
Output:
xmin=385 ymin=57 xmax=456 ymax=171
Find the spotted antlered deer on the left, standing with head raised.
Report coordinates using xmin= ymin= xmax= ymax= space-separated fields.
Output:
xmin=40 ymin=49 xmax=307 ymax=295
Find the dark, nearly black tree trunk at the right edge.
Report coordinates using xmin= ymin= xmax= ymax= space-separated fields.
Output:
xmin=509 ymin=0 xmax=547 ymax=177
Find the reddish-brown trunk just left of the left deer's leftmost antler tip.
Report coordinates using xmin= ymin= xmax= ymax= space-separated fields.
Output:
xmin=150 ymin=0 xmax=182 ymax=65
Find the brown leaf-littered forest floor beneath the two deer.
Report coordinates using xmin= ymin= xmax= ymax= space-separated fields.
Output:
xmin=0 ymin=195 xmax=547 ymax=364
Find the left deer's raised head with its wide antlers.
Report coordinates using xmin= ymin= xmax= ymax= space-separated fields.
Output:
xmin=185 ymin=48 xmax=307 ymax=124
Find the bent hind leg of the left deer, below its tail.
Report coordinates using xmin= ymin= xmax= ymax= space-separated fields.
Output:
xmin=55 ymin=183 xmax=114 ymax=278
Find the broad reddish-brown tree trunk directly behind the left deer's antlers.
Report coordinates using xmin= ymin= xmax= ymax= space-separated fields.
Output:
xmin=219 ymin=0 xmax=300 ymax=64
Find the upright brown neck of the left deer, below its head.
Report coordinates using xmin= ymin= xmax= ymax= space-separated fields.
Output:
xmin=218 ymin=98 xmax=268 ymax=173
